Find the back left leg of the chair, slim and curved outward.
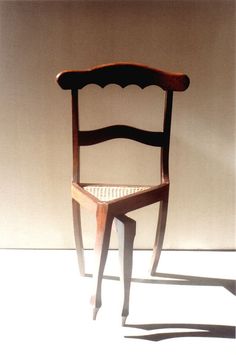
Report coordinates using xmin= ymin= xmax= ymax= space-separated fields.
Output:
xmin=72 ymin=199 xmax=85 ymax=276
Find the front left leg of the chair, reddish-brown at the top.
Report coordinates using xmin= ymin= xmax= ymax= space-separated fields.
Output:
xmin=91 ymin=205 xmax=113 ymax=320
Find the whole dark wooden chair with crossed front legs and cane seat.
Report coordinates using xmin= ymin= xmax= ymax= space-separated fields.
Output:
xmin=57 ymin=63 xmax=189 ymax=324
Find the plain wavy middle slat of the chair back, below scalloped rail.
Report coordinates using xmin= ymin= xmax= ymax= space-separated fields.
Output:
xmin=78 ymin=125 xmax=164 ymax=147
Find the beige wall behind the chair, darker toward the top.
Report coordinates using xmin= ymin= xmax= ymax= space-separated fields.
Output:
xmin=0 ymin=0 xmax=235 ymax=249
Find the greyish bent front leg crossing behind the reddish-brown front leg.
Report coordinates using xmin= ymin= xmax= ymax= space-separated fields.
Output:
xmin=115 ymin=215 xmax=136 ymax=326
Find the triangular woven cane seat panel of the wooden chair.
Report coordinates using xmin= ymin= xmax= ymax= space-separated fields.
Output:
xmin=84 ymin=185 xmax=149 ymax=202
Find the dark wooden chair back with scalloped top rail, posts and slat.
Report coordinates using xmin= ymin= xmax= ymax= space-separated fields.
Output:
xmin=57 ymin=63 xmax=189 ymax=183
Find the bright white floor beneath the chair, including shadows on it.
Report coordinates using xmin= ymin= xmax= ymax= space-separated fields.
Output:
xmin=0 ymin=250 xmax=236 ymax=355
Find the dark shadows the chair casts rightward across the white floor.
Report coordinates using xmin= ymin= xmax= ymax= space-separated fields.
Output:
xmin=85 ymin=272 xmax=236 ymax=341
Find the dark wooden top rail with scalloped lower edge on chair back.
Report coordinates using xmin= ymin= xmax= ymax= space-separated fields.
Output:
xmin=57 ymin=63 xmax=190 ymax=91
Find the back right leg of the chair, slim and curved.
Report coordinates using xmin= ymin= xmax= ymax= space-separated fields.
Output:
xmin=150 ymin=195 xmax=168 ymax=276
